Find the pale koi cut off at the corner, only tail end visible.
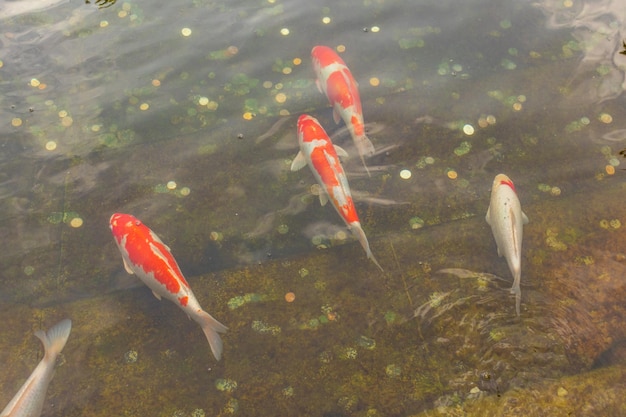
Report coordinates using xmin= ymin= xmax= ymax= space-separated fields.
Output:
xmin=0 ymin=319 xmax=72 ymax=417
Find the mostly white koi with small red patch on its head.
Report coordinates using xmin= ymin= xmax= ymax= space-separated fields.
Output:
xmin=485 ymin=174 xmax=528 ymax=316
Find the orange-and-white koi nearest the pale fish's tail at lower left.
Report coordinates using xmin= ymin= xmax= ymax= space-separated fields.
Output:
xmin=110 ymin=213 xmax=228 ymax=360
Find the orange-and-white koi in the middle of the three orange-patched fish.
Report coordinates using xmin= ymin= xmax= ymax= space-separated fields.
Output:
xmin=291 ymin=114 xmax=383 ymax=271
